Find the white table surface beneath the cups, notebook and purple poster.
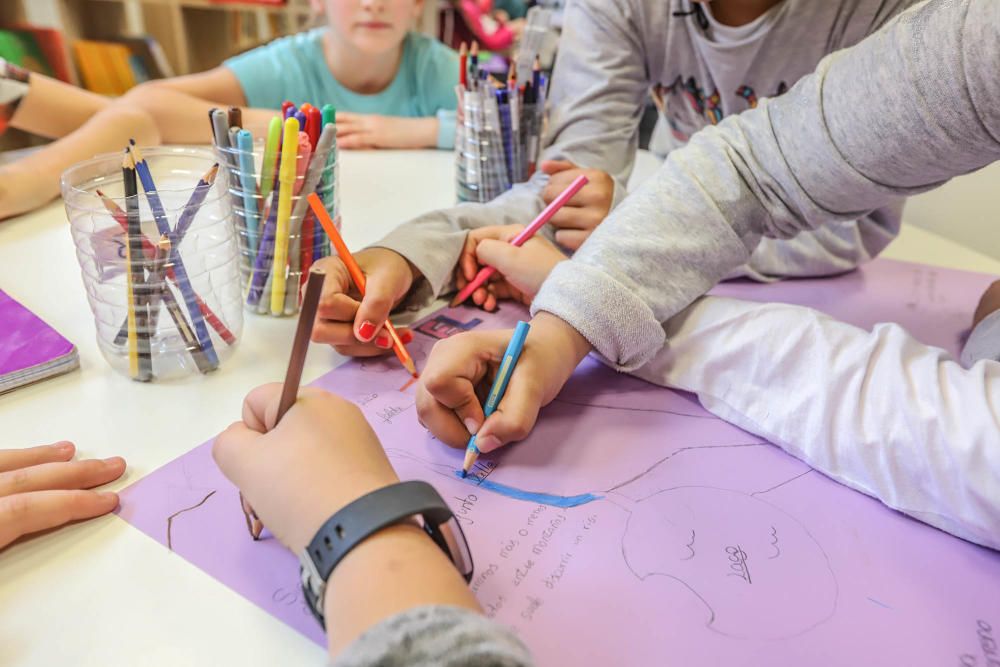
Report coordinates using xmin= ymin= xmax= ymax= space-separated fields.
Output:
xmin=0 ymin=151 xmax=1000 ymax=667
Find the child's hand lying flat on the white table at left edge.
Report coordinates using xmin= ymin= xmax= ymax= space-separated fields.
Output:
xmin=0 ymin=442 xmax=125 ymax=549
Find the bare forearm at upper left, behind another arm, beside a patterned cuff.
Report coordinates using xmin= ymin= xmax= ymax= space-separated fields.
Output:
xmin=11 ymin=73 xmax=113 ymax=139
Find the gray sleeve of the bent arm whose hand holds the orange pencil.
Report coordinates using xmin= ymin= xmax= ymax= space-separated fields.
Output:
xmin=375 ymin=0 xmax=649 ymax=306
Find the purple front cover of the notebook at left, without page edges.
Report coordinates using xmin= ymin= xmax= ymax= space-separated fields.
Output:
xmin=0 ymin=290 xmax=74 ymax=378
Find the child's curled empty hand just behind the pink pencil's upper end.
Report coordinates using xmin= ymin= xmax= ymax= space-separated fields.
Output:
xmin=538 ymin=160 xmax=615 ymax=250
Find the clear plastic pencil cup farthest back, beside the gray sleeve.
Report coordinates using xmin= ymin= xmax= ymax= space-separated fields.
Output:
xmin=455 ymin=86 xmax=541 ymax=203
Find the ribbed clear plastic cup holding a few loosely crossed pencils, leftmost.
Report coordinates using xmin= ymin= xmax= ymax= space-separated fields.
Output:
xmin=62 ymin=147 xmax=243 ymax=381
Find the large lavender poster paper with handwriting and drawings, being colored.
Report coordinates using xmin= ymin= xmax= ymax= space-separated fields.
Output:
xmin=120 ymin=260 xmax=1000 ymax=667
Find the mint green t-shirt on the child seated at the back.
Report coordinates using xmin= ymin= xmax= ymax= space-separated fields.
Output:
xmin=224 ymin=28 xmax=458 ymax=148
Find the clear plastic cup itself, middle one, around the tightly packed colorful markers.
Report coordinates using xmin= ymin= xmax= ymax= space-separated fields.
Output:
xmin=216 ymin=141 xmax=340 ymax=316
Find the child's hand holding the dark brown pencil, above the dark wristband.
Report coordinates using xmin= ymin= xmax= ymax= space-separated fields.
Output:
xmin=212 ymin=383 xmax=399 ymax=553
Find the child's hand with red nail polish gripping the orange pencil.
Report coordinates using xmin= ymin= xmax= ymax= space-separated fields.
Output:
xmin=312 ymin=248 xmax=417 ymax=357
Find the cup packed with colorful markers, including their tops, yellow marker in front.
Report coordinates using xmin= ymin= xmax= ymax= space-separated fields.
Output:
xmin=212 ymin=102 xmax=340 ymax=316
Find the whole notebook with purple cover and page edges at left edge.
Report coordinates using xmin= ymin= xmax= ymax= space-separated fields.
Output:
xmin=0 ymin=290 xmax=80 ymax=394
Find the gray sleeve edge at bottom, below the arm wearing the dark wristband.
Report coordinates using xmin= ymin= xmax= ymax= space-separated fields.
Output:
xmin=331 ymin=606 xmax=534 ymax=667
